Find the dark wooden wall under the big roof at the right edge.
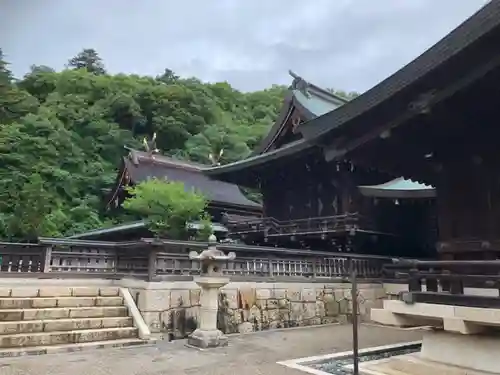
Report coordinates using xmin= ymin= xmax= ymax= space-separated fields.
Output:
xmin=437 ymin=134 xmax=500 ymax=259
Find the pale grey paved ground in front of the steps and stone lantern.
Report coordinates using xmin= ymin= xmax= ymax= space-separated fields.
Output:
xmin=0 ymin=325 xmax=422 ymax=375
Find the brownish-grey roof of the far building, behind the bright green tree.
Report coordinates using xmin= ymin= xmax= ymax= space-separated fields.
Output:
xmin=123 ymin=150 xmax=261 ymax=210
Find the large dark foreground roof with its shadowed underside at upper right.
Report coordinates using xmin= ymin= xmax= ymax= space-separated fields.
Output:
xmin=306 ymin=1 xmax=500 ymax=185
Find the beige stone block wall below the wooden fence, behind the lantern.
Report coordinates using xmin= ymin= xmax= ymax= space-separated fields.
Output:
xmin=123 ymin=281 xmax=386 ymax=338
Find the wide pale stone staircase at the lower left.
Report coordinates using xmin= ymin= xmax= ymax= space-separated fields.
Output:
xmin=0 ymin=287 xmax=148 ymax=357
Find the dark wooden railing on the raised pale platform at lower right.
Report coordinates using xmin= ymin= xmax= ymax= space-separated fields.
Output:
xmin=384 ymin=260 xmax=500 ymax=308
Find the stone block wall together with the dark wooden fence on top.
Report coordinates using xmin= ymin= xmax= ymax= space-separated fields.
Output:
xmin=0 ymin=239 xmax=398 ymax=338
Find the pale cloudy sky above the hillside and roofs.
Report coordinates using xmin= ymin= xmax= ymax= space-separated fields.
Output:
xmin=0 ymin=0 xmax=488 ymax=92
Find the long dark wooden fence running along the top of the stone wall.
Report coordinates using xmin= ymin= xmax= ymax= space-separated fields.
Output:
xmin=0 ymin=239 xmax=390 ymax=279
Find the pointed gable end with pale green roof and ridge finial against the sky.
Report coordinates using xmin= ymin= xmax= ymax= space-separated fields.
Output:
xmin=252 ymin=71 xmax=347 ymax=155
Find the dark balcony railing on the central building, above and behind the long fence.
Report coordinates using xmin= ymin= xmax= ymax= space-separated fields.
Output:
xmin=223 ymin=213 xmax=375 ymax=237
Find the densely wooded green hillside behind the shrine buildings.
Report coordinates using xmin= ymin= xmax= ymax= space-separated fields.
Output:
xmin=0 ymin=49 xmax=354 ymax=240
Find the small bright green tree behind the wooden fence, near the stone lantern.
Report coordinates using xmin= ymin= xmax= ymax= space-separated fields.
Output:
xmin=123 ymin=179 xmax=209 ymax=239
